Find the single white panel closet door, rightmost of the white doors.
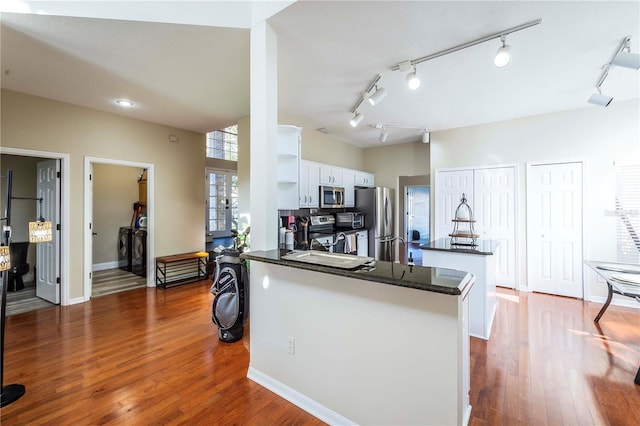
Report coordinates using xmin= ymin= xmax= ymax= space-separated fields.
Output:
xmin=527 ymin=163 xmax=583 ymax=298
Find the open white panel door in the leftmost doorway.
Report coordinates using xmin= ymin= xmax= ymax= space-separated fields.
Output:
xmin=36 ymin=160 xmax=60 ymax=305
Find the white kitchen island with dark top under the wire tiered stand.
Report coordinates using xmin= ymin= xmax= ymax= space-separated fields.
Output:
xmin=420 ymin=238 xmax=499 ymax=340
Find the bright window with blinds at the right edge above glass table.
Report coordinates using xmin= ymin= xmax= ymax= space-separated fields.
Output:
xmin=615 ymin=162 xmax=640 ymax=264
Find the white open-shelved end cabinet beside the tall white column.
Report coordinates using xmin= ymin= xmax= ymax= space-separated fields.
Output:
xmin=277 ymin=125 xmax=302 ymax=210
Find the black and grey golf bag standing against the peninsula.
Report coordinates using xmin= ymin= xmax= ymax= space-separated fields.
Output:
xmin=211 ymin=249 xmax=249 ymax=343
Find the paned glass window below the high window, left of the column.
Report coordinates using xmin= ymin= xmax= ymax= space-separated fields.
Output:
xmin=206 ymin=168 xmax=238 ymax=238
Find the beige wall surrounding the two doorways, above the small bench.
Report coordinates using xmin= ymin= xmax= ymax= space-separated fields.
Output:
xmin=1 ymin=90 xmax=205 ymax=300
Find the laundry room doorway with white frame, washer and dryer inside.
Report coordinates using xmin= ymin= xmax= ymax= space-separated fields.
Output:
xmin=84 ymin=157 xmax=155 ymax=300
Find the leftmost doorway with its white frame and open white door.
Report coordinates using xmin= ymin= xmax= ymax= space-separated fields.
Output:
xmin=0 ymin=147 xmax=70 ymax=313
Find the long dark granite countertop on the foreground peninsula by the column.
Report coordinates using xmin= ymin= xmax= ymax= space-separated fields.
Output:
xmin=241 ymin=250 xmax=471 ymax=295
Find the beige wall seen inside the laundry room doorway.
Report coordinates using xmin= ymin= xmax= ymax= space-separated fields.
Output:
xmin=92 ymin=164 xmax=143 ymax=265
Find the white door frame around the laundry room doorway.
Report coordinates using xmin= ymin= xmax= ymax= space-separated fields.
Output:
xmin=83 ymin=156 xmax=156 ymax=302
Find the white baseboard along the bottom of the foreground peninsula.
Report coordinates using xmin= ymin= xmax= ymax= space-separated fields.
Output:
xmin=247 ymin=366 xmax=356 ymax=425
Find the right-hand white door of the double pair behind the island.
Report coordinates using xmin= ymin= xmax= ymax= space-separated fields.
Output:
xmin=472 ymin=167 xmax=516 ymax=288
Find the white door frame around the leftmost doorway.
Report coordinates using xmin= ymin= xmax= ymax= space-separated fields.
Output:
xmin=0 ymin=146 xmax=70 ymax=306
